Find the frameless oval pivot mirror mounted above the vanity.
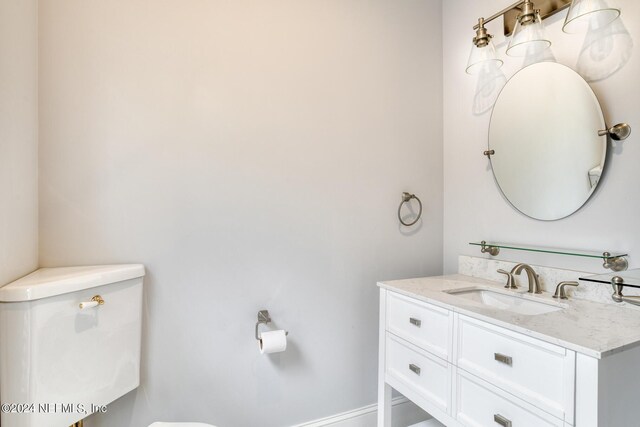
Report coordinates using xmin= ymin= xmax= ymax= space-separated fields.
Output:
xmin=489 ymin=62 xmax=607 ymax=220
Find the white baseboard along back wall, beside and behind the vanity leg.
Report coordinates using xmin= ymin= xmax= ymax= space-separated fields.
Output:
xmin=293 ymin=396 xmax=430 ymax=427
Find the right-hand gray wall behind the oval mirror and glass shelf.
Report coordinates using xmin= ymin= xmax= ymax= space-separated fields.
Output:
xmin=443 ymin=0 xmax=640 ymax=272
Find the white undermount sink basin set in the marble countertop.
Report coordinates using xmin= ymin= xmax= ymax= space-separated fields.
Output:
xmin=444 ymin=287 xmax=564 ymax=316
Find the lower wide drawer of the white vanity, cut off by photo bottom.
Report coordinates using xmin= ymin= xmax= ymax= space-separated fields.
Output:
xmin=455 ymin=370 xmax=564 ymax=427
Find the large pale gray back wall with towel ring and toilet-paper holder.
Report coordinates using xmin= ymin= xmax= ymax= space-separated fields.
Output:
xmin=40 ymin=0 xmax=442 ymax=427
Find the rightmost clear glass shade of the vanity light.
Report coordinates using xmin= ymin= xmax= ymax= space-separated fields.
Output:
xmin=562 ymin=0 xmax=620 ymax=34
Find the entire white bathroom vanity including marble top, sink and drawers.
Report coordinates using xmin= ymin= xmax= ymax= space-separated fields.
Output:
xmin=378 ymin=274 xmax=640 ymax=427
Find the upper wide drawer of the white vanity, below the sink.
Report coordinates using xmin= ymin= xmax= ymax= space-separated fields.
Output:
xmin=455 ymin=315 xmax=575 ymax=423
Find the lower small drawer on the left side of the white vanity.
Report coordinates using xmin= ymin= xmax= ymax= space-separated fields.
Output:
xmin=385 ymin=334 xmax=452 ymax=413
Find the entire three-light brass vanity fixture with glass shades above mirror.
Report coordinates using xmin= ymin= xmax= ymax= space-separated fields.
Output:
xmin=466 ymin=0 xmax=620 ymax=74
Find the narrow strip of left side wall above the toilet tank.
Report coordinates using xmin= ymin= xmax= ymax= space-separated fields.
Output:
xmin=0 ymin=0 xmax=38 ymax=285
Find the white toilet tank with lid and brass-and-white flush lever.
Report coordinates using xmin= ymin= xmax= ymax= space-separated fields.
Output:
xmin=0 ymin=264 xmax=145 ymax=427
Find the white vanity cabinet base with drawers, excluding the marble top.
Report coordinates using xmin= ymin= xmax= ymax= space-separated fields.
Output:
xmin=378 ymin=288 xmax=640 ymax=427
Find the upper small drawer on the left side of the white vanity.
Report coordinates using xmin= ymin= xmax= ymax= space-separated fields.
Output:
xmin=387 ymin=292 xmax=453 ymax=361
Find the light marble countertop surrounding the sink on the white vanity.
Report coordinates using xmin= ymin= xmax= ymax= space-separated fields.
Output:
xmin=378 ymin=274 xmax=640 ymax=359
